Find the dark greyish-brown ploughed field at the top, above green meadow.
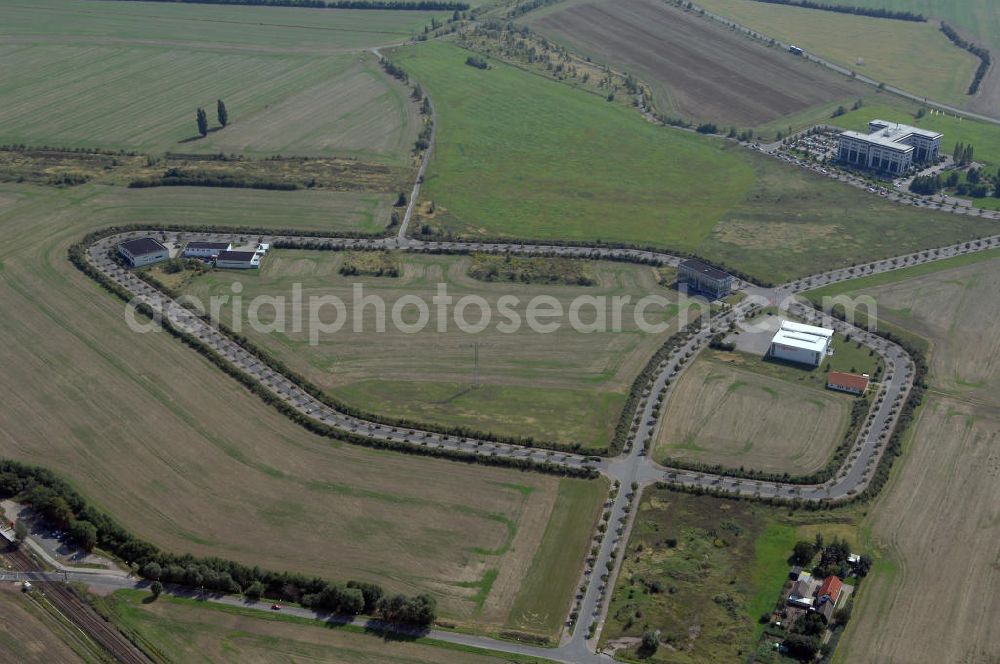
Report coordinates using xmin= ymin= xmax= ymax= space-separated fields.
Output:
xmin=531 ymin=0 xmax=861 ymax=127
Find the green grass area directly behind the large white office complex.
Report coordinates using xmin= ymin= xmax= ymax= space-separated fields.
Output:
xmin=823 ymin=105 xmax=1000 ymax=168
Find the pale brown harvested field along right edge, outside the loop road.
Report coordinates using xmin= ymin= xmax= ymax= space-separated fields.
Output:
xmin=836 ymin=258 xmax=1000 ymax=664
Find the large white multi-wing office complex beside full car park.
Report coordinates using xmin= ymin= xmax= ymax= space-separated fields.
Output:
xmin=837 ymin=120 xmax=943 ymax=175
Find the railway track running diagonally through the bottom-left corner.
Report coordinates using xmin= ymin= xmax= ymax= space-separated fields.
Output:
xmin=3 ymin=548 xmax=152 ymax=664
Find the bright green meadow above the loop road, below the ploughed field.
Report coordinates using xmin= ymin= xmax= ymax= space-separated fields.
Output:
xmin=393 ymin=42 xmax=993 ymax=282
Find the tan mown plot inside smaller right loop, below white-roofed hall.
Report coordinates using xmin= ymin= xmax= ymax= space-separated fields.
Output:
xmin=655 ymin=358 xmax=851 ymax=474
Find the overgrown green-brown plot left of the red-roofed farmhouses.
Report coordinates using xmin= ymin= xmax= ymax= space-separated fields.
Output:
xmin=601 ymin=487 xmax=857 ymax=664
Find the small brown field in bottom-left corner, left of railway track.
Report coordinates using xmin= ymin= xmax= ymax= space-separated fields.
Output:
xmin=0 ymin=582 xmax=89 ymax=664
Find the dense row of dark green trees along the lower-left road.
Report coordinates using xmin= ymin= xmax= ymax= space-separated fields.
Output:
xmin=0 ymin=460 xmax=437 ymax=627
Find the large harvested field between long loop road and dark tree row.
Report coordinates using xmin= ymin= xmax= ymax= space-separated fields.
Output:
xmin=0 ymin=185 xmax=606 ymax=631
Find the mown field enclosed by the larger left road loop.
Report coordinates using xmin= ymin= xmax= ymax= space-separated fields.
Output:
xmin=185 ymin=250 xmax=694 ymax=448
